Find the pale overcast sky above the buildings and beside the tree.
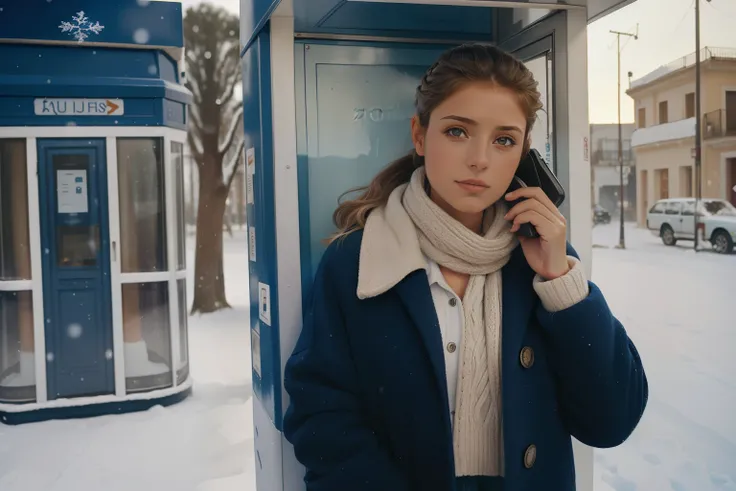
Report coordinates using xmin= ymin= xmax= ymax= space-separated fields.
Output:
xmin=171 ymin=0 xmax=736 ymax=123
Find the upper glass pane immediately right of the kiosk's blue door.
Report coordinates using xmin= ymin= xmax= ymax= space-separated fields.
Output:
xmin=118 ymin=138 xmax=167 ymax=273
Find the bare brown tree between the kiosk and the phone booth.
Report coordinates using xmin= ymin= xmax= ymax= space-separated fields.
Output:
xmin=184 ymin=3 xmax=244 ymax=313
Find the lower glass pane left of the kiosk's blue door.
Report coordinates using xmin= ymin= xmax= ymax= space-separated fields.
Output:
xmin=0 ymin=291 xmax=36 ymax=402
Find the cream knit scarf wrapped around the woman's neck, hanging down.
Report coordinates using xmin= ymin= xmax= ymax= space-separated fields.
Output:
xmin=402 ymin=167 xmax=518 ymax=476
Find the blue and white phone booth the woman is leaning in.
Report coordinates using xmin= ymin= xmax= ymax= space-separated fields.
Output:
xmin=240 ymin=0 xmax=631 ymax=491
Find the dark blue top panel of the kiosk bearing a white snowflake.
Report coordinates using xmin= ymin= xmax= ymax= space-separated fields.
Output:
xmin=0 ymin=0 xmax=184 ymax=48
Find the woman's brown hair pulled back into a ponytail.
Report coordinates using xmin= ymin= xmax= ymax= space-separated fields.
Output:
xmin=327 ymin=43 xmax=542 ymax=243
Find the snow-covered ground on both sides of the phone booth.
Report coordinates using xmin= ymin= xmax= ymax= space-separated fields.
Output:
xmin=0 ymin=224 xmax=736 ymax=491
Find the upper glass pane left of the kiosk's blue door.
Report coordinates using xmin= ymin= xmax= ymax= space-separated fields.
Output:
xmin=0 ymin=140 xmax=31 ymax=280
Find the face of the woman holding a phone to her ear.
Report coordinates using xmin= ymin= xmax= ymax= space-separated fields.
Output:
xmin=412 ymin=82 xmax=526 ymax=224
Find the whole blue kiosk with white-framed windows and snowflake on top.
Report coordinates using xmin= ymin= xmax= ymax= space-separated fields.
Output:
xmin=0 ymin=0 xmax=192 ymax=424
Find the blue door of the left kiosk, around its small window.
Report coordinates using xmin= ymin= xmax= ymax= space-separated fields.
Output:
xmin=38 ymin=138 xmax=115 ymax=400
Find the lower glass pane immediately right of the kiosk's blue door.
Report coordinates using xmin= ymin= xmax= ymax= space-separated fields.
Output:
xmin=122 ymin=281 xmax=172 ymax=393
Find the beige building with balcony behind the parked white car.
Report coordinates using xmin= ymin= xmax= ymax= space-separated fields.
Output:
xmin=627 ymin=48 xmax=736 ymax=226
